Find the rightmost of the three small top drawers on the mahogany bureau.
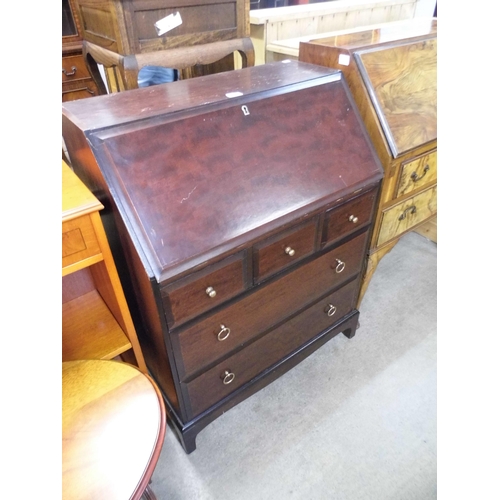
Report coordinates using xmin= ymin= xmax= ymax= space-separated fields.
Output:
xmin=324 ymin=190 xmax=377 ymax=245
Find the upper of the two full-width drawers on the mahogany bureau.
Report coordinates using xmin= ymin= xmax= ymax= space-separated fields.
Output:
xmin=178 ymin=233 xmax=366 ymax=379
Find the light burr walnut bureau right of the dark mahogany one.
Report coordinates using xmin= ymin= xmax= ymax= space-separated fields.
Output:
xmin=299 ymin=18 xmax=437 ymax=299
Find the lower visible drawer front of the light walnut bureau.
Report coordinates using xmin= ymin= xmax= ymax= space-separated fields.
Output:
xmin=377 ymin=186 xmax=437 ymax=246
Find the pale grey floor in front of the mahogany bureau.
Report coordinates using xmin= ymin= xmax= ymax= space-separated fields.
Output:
xmin=152 ymin=233 xmax=437 ymax=500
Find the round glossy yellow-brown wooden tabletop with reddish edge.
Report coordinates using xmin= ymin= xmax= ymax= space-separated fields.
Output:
xmin=62 ymin=360 xmax=166 ymax=500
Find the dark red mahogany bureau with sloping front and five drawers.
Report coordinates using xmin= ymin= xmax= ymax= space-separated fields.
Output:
xmin=63 ymin=61 xmax=383 ymax=453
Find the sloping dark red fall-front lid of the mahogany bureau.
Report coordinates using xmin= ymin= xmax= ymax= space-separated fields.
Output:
xmin=85 ymin=70 xmax=380 ymax=281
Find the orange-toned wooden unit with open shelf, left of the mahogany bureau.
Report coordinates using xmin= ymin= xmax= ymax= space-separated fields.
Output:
xmin=62 ymin=161 xmax=147 ymax=372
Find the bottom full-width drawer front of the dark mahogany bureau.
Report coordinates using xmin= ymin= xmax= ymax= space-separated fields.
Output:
xmin=187 ymin=280 xmax=358 ymax=416
